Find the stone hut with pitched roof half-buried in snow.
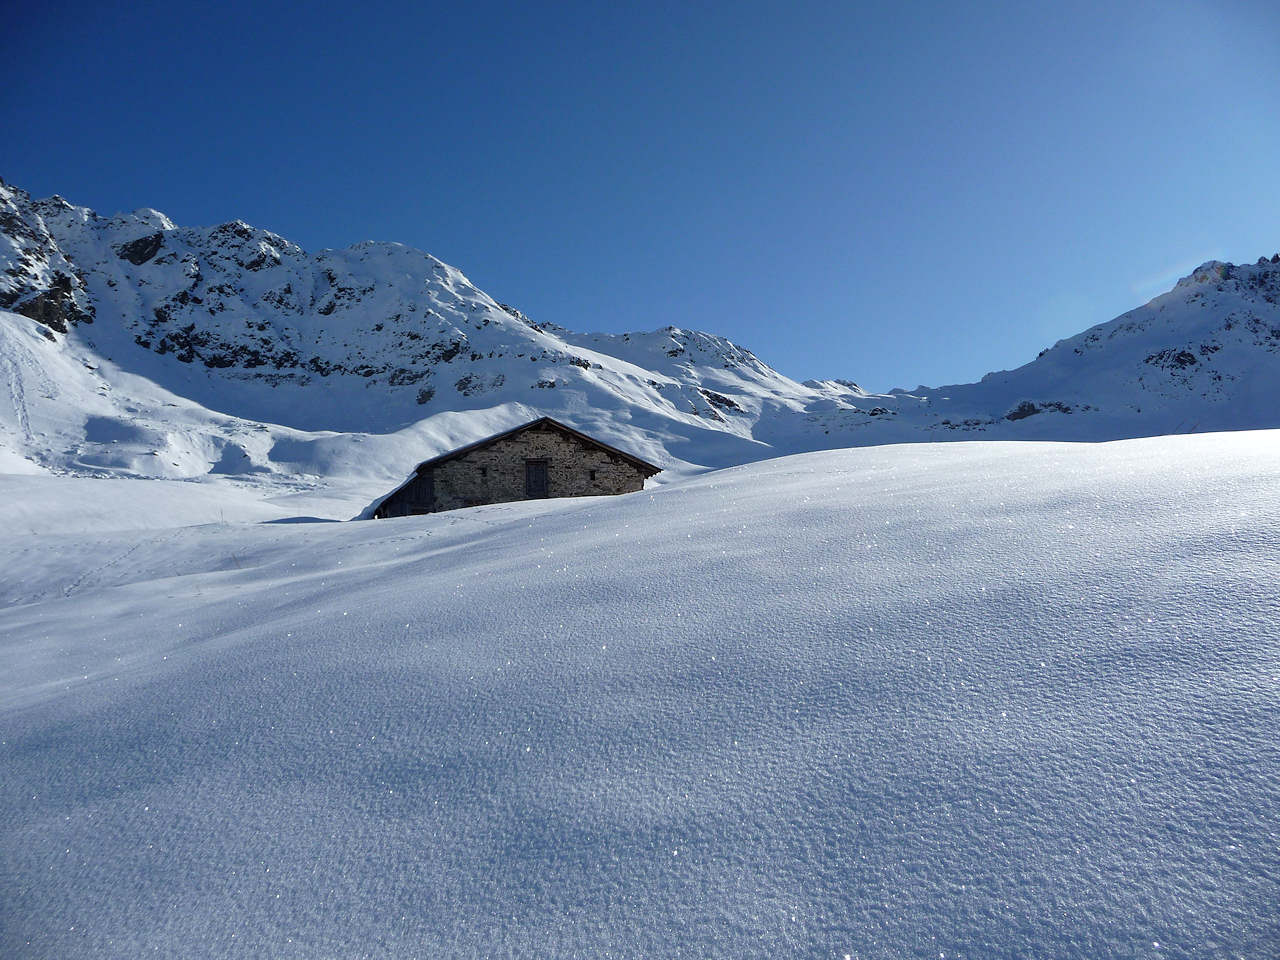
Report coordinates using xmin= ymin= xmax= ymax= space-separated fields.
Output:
xmin=365 ymin=417 xmax=660 ymax=520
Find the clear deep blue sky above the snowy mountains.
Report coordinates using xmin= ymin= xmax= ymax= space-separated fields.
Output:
xmin=0 ymin=0 xmax=1280 ymax=389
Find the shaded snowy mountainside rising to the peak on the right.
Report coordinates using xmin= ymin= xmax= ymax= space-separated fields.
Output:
xmin=875 ymin=261 xmax=1280 ymax=440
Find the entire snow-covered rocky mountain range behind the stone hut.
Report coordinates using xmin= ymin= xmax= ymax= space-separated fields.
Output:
xmin=0 ymin=177 xmax=1280 ymax=499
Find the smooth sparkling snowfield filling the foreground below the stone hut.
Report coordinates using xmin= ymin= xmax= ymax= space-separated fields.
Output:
xmin=0 ymin=431 xmax=1280 ymax=959
